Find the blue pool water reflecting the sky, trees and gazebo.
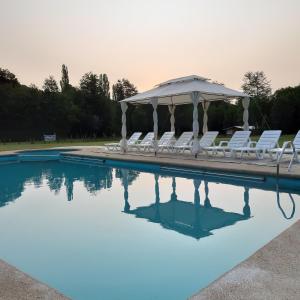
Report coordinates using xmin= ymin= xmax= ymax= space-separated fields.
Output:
xmin=0 ymin=159 xmax=300 ymax=300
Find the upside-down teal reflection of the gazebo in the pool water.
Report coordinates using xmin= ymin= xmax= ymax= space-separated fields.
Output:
xmin=124 ymin=175 xmax=251 ymax=239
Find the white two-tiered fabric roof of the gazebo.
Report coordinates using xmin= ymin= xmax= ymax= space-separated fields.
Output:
xmin=122 ymin=75 xmax=249 ymax=105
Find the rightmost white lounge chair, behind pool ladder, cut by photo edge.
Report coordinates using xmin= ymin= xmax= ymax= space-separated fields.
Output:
xmin=271 ymin=130 xmax=300 ymax=170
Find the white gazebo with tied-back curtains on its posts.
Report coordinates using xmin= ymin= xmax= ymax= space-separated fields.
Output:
xmin=120 ymin=75 xmax=250 ymax=155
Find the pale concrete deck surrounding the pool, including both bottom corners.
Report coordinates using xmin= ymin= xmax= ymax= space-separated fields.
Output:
xmin=0 ymin=147 xmax=300 ymax=300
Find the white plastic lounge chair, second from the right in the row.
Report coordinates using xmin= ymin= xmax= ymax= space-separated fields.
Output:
xmin=234 ymin=130 xmax=281 ymax=159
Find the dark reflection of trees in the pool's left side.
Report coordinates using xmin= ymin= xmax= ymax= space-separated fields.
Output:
xmin=0 ymin=162 xmax=113 ymax=206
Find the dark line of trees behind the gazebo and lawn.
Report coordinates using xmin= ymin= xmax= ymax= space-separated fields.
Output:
xmin=0 ymin=65 xmax=300 ymax=142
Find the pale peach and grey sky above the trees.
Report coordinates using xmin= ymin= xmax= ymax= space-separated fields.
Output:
xmin=0 ymin=0 xmax=300 ymax=91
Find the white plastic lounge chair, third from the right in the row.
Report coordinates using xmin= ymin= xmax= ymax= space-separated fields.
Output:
xmin=202 ymin=130 xmax=251 ymax=157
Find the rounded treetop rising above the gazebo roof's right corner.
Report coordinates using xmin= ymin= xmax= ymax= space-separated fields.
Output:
xmin=242 ymin=71 xmax=272 ymax=99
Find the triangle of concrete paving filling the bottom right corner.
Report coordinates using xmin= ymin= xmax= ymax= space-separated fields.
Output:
xmin=191 ymin=221 xmax=300 ymax=300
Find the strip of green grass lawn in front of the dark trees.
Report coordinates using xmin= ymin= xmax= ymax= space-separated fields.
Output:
xmin=0 ymin=135 xmax=294 ymax=151
